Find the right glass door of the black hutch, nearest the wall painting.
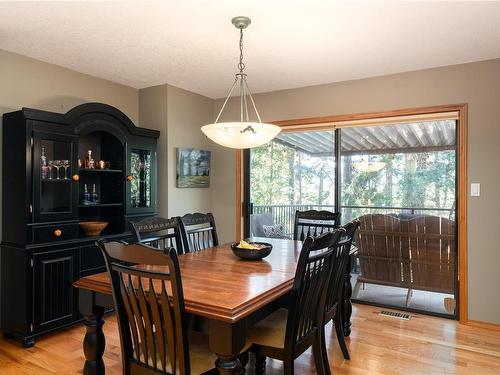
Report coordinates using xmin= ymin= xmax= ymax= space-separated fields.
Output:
xmin=127 ymin=147 xmax=156 ymax=213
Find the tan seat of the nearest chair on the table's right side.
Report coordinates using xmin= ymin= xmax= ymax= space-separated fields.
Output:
xmin=247 ymin=308 xmax=288 ymax=349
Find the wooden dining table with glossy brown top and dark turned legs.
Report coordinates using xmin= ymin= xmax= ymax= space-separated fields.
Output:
xmin=74 ymin=238 xmax=352 ymax=375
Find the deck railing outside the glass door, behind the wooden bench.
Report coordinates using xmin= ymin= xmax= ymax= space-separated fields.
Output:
xmin=253 ymin=204 xmax=455 ymax=236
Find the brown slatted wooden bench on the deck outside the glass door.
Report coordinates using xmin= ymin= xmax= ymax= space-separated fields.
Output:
xmin=354 ymin=214 xmax=456 ymax=305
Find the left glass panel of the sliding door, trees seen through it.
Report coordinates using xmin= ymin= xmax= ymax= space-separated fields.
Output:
xmin=249 ymin=130 xmax=335 ymax=238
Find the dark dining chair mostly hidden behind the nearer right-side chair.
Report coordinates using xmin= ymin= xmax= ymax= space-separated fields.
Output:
xmin=321 ymin=219 xmax=360 ymax=368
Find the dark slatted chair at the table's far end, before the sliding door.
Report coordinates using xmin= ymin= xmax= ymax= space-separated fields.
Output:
xmin=293 ymin=210 xmax=340 ymax=241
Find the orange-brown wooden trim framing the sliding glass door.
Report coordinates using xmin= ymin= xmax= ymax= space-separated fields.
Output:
xmin=236 ymin=103 xmax=469 ymax=324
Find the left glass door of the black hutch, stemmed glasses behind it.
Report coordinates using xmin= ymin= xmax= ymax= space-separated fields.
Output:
xmin=33 ymin=133 xmax=76 ymax=221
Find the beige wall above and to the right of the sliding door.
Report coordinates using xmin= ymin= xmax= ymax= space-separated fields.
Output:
xmin=214 ymin=59 xmax=500 ymax=323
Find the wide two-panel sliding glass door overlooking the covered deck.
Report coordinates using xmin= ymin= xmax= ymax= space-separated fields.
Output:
xmin=245 ymin=119 xmax=458 ymax=317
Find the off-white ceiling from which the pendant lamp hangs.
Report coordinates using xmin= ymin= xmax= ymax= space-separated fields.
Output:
xmin=0 ymin=0 xmax=500 ymax=98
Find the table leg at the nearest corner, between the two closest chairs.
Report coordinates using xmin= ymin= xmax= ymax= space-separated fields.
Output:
xmin=209 ymin=319 xmax=245 ymax=375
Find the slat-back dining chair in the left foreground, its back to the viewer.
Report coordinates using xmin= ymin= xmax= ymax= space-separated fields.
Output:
xmin=97 ymin=240 xmax=216 ymax=375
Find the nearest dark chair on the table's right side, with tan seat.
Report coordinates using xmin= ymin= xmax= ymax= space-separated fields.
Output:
xmin=247 ymin=229 xmax=344 ymax=375
